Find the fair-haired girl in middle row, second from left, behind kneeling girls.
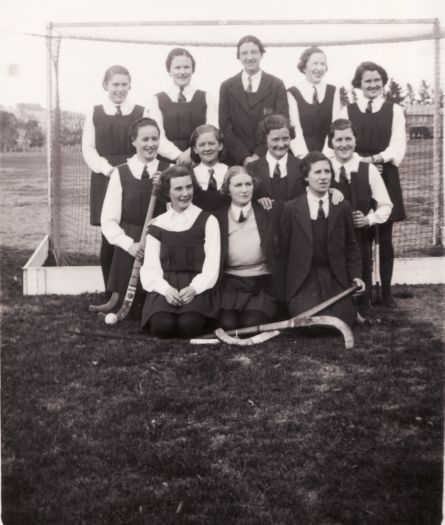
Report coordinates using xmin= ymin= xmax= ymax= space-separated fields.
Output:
xmin=190 ymin=124 xmax=230 ymax=213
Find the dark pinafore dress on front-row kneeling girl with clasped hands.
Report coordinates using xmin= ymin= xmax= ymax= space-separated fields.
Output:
xmin=142 ymin=211 xmax=219 ymax=326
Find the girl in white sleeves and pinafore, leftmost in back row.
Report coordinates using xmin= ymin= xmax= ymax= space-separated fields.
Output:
xmin=82 ymin=62 xmax=144 ymax=294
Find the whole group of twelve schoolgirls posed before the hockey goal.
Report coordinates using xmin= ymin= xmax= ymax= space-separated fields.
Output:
xmin=83 ymin=36 xmax=404 ymax=337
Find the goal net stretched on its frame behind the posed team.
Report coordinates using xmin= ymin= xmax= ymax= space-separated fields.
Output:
xmin=47 ymin=20 xmax=444 ymax=265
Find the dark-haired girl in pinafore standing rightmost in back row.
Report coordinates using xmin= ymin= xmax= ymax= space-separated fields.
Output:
xmin=344 ymin=62 xmax=406 ymax=308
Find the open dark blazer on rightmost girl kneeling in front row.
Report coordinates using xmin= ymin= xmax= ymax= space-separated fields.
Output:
xmin=280 ymin=195 xmax=362 ymax=301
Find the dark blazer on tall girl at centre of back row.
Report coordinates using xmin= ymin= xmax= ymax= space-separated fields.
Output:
xmin=219 ymin=71 xmax=289 ymax=165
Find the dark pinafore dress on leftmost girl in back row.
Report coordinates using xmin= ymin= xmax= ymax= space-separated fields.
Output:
xmin=90 ymin=105 xmax=144 ymax=226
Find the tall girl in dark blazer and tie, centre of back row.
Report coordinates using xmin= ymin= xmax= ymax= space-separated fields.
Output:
xmin=219 ymin=35 xmax=289 ymax=166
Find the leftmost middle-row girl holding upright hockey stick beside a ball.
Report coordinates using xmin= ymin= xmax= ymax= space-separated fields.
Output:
xmin=101 ymin=118 xmax=168 ymax=316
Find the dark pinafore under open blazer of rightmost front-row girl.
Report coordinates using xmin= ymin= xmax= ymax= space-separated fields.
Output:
xmin=289 ymin=210 xmax=357 ymax=326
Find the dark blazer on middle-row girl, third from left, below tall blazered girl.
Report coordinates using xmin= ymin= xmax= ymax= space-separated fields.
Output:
xmin=247 ymin=155 xmax=306 ymax=201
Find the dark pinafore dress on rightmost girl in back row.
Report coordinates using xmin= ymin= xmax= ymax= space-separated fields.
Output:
xmin=348 ymin=101 xmax=406 ymax=222
